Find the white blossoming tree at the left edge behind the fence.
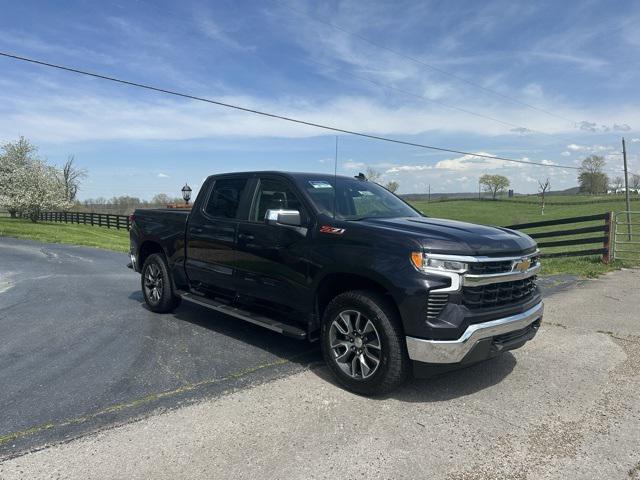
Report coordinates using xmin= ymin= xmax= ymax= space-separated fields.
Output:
xmin=0 ymin=138 xmax=71 ymax=222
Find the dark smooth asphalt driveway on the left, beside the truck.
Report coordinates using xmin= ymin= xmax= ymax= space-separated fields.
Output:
xmin=0 ymin=238 xmax=319 ymax=456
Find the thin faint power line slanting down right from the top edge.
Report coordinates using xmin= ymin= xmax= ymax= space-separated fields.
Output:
xmin=278 ymin=2 xmax=579 ymax=125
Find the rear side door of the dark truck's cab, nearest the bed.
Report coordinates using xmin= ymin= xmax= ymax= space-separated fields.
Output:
xmin=185 ymin=175 xmax=252 ymax=302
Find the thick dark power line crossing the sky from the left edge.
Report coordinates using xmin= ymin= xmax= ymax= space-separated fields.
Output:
xmin=0 ymin=51 xmax=624 ymax=174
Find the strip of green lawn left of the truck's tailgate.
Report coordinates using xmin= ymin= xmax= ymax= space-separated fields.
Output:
xmin=0 ymin=217 xmax=129 ymax=252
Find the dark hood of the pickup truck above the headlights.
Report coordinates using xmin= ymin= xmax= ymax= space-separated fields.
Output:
xmin=359 ymin=217 xmax=536 ymax=255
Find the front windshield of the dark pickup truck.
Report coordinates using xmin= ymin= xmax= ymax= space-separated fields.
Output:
xmin=302 ymin=177 xmax=420 ymax=220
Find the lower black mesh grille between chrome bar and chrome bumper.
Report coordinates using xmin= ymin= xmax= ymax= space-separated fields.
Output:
xmin=462 ymin=277 xmax=536 ymax=309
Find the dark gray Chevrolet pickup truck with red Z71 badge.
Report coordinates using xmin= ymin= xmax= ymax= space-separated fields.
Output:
xmin=131 ymin=172 xmax=543 ymax=394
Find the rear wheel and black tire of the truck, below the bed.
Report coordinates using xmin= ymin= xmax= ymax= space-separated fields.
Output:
xmin=140 ymin=253 xmax=182 ymax=313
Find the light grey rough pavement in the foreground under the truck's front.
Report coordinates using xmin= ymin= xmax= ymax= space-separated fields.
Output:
xmin=0 ymin=251 xmax=640 ymax=480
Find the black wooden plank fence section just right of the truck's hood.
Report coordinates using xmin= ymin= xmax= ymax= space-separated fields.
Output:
xmin=507 ymin=212 xmax=613 ymax=263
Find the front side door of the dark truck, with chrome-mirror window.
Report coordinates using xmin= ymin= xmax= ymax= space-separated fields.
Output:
xmin=237 ymin=175 xmax=312 ymax=314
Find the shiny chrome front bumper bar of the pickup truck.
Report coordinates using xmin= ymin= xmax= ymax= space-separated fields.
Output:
xmin=406 ymin=302 xmax=544 ymax=363
